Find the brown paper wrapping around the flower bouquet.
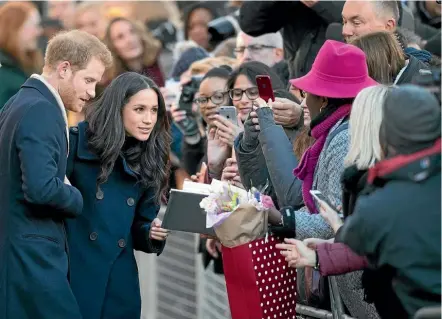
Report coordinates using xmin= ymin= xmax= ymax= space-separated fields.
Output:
xmin=214 ymin=204 xmax=268 ymax=247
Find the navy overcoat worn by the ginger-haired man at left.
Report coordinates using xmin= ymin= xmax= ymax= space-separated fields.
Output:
xmin=0 ymin=78 xmax=83 ymax=319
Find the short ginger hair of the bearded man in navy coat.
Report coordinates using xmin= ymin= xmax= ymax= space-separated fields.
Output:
xmin=45 ymin=30 xmax=112 ymax=70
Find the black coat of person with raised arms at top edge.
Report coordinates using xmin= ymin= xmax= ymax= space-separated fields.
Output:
xmin=239 ymin=1 xmax=344 ymax=78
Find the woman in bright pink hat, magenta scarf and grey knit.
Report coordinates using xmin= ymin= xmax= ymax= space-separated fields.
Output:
xmin=257 ymin=40 xmax=377 ymax=316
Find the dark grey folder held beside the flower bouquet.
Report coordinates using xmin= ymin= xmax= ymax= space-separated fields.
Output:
xmin=161 ymin=189 xmax=215 ymax=236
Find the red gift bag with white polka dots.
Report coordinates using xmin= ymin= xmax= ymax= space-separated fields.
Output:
xmin=222 ymin=236 xmax=296 ymax=319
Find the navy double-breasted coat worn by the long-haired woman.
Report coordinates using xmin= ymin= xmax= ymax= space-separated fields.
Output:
xmin=67 ymin=122 xmax=164 ymax=319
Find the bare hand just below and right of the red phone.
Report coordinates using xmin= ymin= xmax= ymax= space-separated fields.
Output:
xmin=270 ymin=97 xmax=302 ymax=128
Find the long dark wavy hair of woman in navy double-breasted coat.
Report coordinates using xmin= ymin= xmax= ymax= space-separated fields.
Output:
xmin=86 ymin=72 xmax=171 ymax=202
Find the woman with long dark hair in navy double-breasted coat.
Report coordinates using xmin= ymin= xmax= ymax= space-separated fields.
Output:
xmin=67 ymin=72 xmax=170 ymax=319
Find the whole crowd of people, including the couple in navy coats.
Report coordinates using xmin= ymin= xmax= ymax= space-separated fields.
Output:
xmin=0 ymin=0 xmax=441 ymax=319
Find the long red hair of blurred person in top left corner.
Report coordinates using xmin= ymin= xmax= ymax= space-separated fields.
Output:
xmin=0 ymin=2 xmax=43 ymax=74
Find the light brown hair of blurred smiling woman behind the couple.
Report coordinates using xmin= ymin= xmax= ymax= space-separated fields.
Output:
xmin=104 ymin=17 xmax=161 ymax=79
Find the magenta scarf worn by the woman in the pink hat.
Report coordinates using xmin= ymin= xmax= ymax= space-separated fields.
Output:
xmin=293 ymin=104 xmax=351 ymax=214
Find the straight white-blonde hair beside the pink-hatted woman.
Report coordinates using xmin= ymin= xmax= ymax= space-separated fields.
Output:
xmin=344 ymin=85 xmax=389 ymax=170
